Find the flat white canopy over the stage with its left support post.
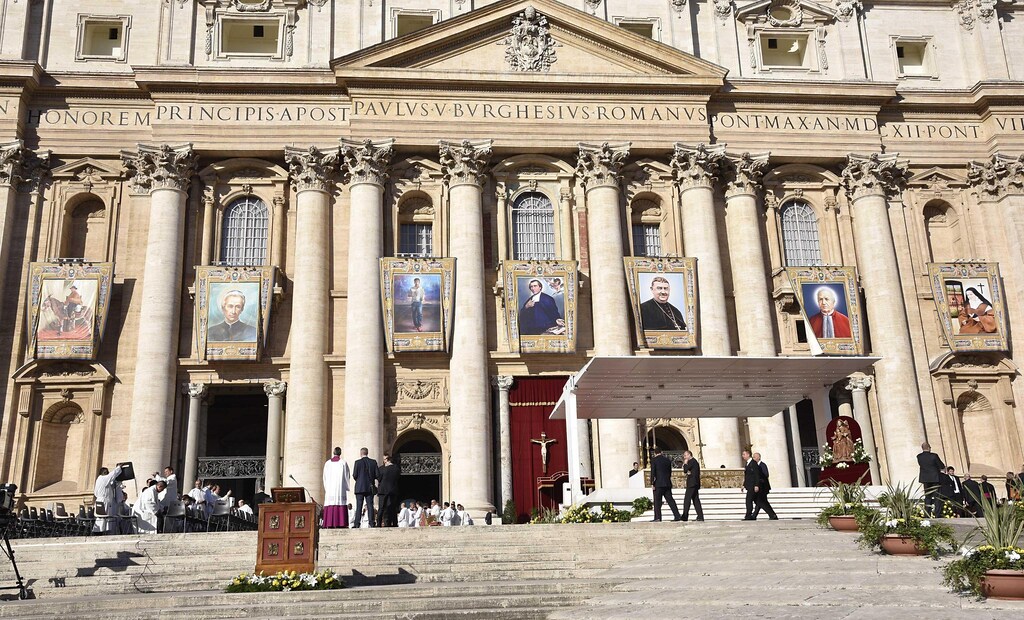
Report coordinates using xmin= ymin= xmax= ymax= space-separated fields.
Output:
xmin=550 ymin=356 xmax=879 ymax=502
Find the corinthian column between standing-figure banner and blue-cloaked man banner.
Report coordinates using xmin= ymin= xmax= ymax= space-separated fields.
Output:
xmin=439 ymin=140 xmax=495 ymax=512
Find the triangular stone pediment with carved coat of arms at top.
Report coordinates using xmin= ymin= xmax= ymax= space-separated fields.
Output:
xmin=332 ymin=0 xmax=726 ymax=88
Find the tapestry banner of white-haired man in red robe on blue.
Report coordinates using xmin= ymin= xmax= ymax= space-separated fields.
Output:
xmin=785 ymin=266 xmax=863 ymax=356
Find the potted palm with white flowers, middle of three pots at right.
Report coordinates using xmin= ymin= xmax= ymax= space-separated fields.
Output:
xmin=857 ymin=484 xmax=955 ymax=557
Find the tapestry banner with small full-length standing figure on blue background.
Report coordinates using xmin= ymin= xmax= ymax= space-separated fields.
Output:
xmin=381 ymin=258 xmax=455 ymax=354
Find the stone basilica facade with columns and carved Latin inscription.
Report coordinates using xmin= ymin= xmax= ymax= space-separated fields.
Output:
xmin=0 ymin=0 xmax=1024 ymax=509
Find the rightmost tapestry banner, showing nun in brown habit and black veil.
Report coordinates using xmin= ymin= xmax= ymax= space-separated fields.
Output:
xmin=928 ymin=262 xmax=1009 ymax=352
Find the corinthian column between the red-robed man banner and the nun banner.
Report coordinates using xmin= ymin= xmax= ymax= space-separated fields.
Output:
xmin=843 ymin=154 xmax=925 ymax=483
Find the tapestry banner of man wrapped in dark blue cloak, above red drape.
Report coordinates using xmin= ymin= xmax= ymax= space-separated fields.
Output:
xmin=503 ymin=260 xmax=577 ymax=354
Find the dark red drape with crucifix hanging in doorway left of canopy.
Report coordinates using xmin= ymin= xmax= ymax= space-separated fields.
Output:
xmin=509 ymin=377 xmax=568 ymax=523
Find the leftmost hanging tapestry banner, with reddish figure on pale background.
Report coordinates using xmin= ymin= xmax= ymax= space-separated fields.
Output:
xmin=29 ymin=262 xmax=114 ymax=360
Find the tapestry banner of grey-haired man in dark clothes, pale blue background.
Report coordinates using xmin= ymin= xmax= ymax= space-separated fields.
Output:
xmin=196 ymin=266 xmax=275 ymax=361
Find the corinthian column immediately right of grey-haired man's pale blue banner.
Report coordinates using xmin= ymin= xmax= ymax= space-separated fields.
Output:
xmin=283 ymin=147 xmax=339 ymax=500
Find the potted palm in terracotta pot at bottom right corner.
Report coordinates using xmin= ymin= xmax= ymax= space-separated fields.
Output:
xmin=942 ymin=489 xmax=1024 ymax=601
